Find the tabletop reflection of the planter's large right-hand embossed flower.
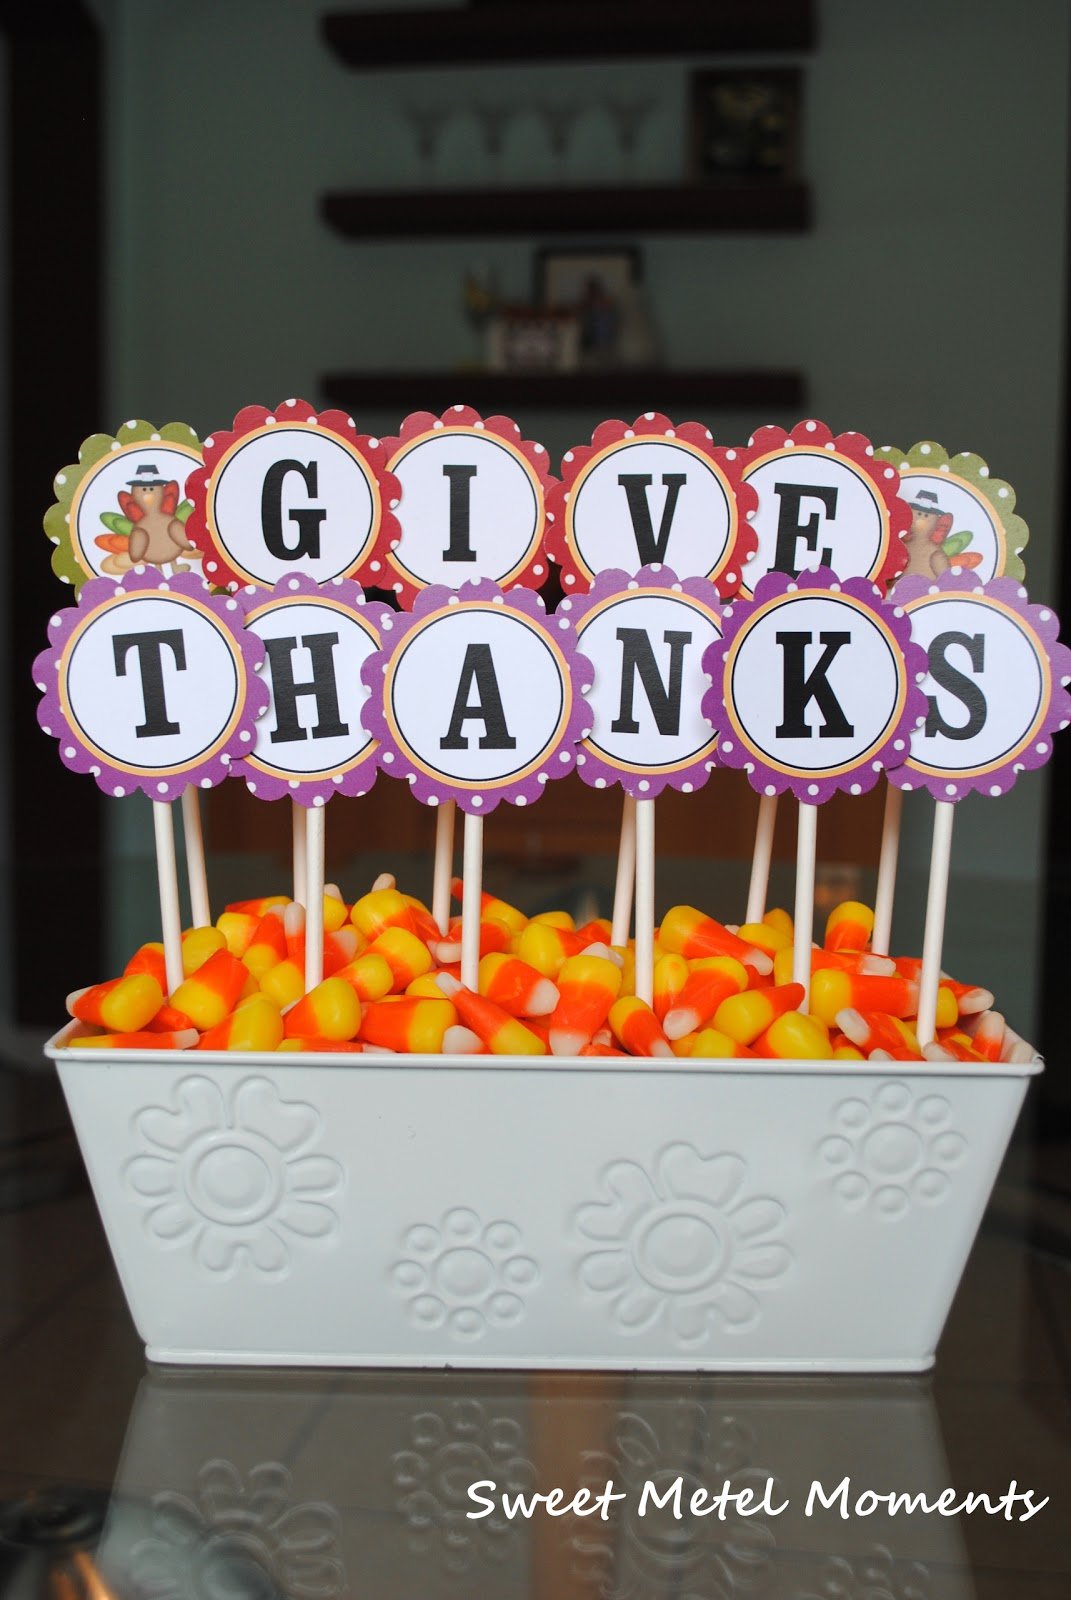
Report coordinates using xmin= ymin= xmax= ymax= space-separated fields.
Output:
xmin=567 ymin=1400 xmax=784 ymax=1600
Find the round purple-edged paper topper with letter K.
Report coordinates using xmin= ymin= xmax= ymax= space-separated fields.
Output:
xmin=703 ymin=571 xmax=925 ymax=805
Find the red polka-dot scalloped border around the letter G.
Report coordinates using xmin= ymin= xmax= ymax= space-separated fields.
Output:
xmin=186 ymin=400 xmax=402 ymax=589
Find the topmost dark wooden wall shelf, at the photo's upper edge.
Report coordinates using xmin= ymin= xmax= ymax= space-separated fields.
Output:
xmin=322 ymin=0 xmax=815 ymax=70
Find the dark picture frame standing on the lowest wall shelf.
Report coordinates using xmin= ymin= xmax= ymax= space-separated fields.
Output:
xmin=535 ymin=245 xmax=644 ymax=366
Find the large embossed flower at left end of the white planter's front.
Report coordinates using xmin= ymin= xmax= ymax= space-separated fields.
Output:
xmin=123 ymin=1074 xmax=343 ymax=1277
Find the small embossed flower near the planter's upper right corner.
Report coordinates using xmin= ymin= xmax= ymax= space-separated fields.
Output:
xmin=818 ymin=1083 xmax=967 ymax=1221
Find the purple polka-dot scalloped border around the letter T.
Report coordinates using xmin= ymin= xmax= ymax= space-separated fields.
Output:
xmin=34 ymin=566 xmax=269 ymax=800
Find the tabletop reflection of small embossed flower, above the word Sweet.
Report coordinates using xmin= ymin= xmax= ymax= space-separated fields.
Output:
xmin=391 ymin=1400 xmax=538 ymax=1573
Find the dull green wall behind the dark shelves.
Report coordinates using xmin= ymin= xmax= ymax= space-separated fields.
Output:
xmin=98 ymin=0 xmax=1071 ymax=1030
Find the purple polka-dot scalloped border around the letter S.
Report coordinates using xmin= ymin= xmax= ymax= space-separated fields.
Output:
xmin=888 ymin=568 xmax=1071 ymax=802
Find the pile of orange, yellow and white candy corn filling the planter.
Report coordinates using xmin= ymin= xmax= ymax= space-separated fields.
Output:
xmin=60 ymin=874 xmax=1033 ymax=1066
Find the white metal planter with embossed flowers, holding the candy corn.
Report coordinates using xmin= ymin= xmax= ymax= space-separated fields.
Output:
xmin=48 ymin=1030 xmax=1041 ymax=1371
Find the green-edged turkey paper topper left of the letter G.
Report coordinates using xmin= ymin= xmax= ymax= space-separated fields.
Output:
xmin=45 ymin=419 xmax=202 ymax=589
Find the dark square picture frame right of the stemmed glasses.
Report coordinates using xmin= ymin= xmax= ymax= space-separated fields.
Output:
xmin=688 ymin=67 xmax=804 ymax=187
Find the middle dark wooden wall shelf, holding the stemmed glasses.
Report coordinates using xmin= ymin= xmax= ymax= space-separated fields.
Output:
xmin=320 ymin=184 xmax=810 ymax=238
